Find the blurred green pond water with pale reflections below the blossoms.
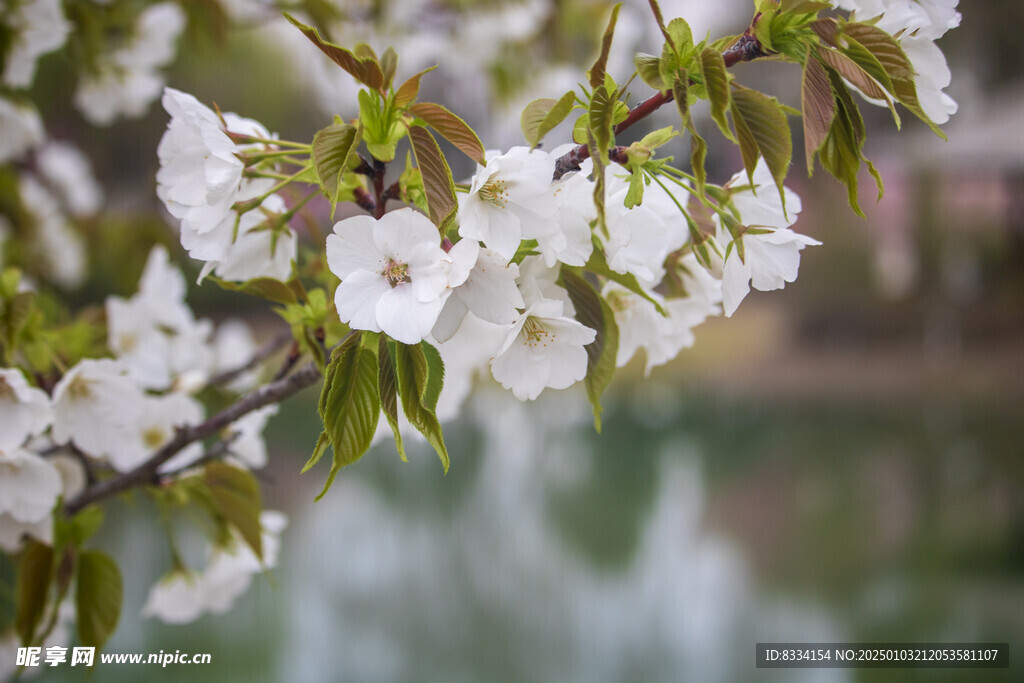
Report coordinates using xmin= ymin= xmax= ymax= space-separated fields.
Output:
xmin=34 ymin=382 xmax=1024 ymax=682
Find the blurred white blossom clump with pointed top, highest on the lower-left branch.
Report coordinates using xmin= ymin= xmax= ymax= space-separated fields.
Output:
xmin=106 ymin=246 xmax=213 ymax=389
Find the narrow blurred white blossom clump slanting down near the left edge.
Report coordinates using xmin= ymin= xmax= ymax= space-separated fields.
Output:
xmin=20 ymin=174 xmax=88 ymax=289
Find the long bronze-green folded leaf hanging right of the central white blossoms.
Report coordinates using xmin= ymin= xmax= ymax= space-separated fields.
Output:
xmin=561 ymin=266 xmax=618 ymax=432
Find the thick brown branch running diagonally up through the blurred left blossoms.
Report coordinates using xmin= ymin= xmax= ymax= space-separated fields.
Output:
xmin=65 ymin=362 xmax=321 ymax=515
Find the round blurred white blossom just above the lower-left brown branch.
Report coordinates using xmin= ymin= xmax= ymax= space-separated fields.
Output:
xmin=50 ymin=358 xmax=144 ymax=458
